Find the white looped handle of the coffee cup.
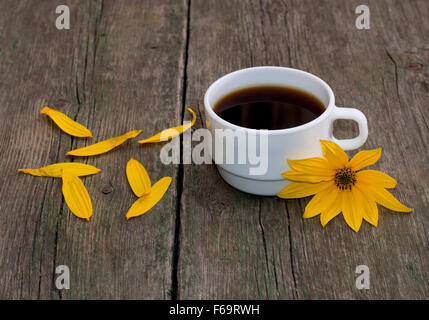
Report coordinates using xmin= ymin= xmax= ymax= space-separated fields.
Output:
xmin=331 ymin=106 xmax=368 ymax=150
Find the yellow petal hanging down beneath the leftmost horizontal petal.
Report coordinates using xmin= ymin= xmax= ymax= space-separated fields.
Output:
xmin=63 ymin=169 xmax=92 ymax=221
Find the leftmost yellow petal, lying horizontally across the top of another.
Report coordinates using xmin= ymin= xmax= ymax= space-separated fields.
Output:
xmin=18 ymin=162 xmax=101 ymax=178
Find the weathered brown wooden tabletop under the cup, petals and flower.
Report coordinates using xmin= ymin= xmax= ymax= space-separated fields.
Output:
xmin=0 ymin=0 xmax=429 ymax=299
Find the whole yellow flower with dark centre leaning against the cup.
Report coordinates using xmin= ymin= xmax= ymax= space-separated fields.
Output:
xmin=277 ymin=140 xmax=413 ymax=232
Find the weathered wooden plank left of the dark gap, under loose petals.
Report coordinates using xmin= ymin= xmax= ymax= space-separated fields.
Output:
xmin=0 ymin=1 xmax=187 ymax=299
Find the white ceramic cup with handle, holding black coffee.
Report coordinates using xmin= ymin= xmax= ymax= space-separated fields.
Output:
xmin=204 ymin=67 xmax=367 ymax=196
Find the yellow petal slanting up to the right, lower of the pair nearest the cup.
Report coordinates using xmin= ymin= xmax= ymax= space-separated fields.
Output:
xmin=126 ymin=177 xmax=172 ymax=220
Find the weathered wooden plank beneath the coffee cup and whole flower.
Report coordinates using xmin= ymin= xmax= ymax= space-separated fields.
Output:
xmin=178 ymin=0 xmax=429 ymax=299
